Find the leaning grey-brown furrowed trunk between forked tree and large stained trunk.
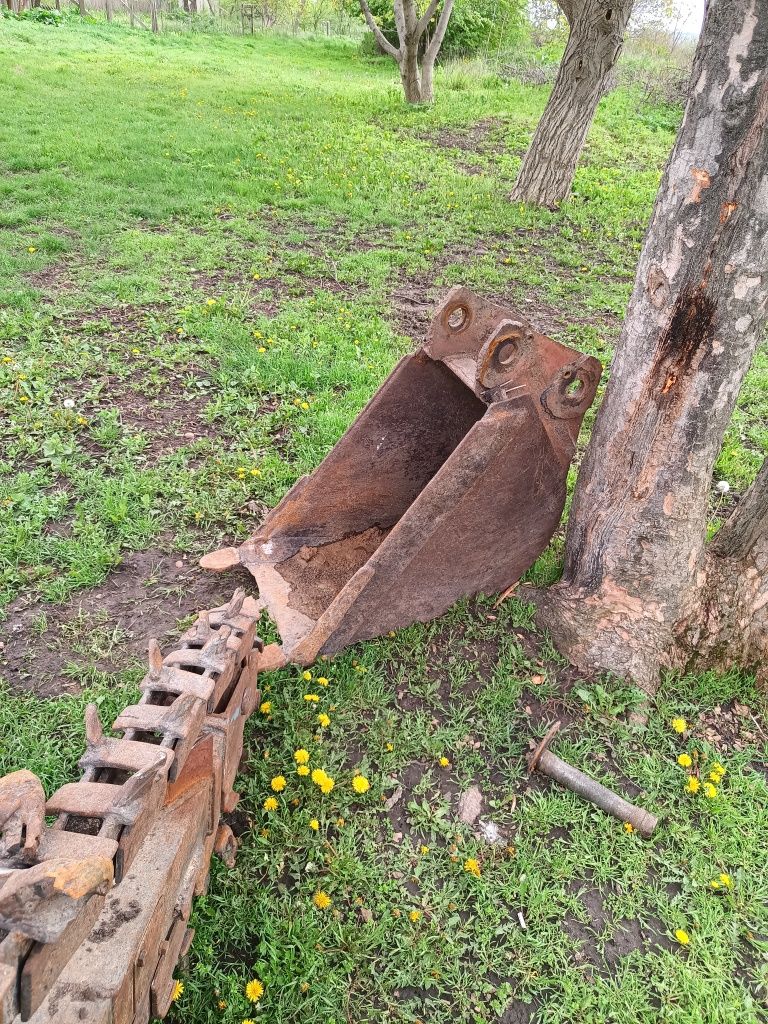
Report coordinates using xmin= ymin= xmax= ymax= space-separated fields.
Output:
xmin=512 ymin=0 xmax=633 ymax=207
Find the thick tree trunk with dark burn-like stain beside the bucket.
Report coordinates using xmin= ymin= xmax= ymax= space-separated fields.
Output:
xmin=539 ymin=0 xmax=768 ymax=692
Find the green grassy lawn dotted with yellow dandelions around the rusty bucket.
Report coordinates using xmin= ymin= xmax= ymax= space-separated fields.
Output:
xmin=0 ymin=22 xmax=768 ymax=1024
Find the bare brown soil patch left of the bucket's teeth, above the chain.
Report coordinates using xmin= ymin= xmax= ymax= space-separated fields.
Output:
xmin=0 ymin=550 xmax=259 ymax=697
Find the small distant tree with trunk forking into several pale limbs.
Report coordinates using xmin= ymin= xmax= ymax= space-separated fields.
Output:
xmin=359 ymin=0 xmax=454 ymax=103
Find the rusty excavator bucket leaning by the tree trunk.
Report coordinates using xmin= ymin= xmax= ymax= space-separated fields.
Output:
xmin=202 ymin=287 xmax=601 ymax=665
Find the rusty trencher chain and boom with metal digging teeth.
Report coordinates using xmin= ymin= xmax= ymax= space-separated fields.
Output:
xmin=0 ymin=591 xmax=262 ymax=1024
